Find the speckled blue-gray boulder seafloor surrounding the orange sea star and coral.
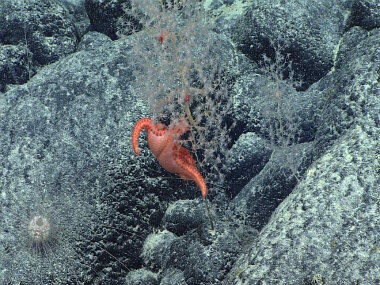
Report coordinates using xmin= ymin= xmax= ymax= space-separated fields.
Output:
xmin=0 ymin=0 xmax=380 ymax=285
